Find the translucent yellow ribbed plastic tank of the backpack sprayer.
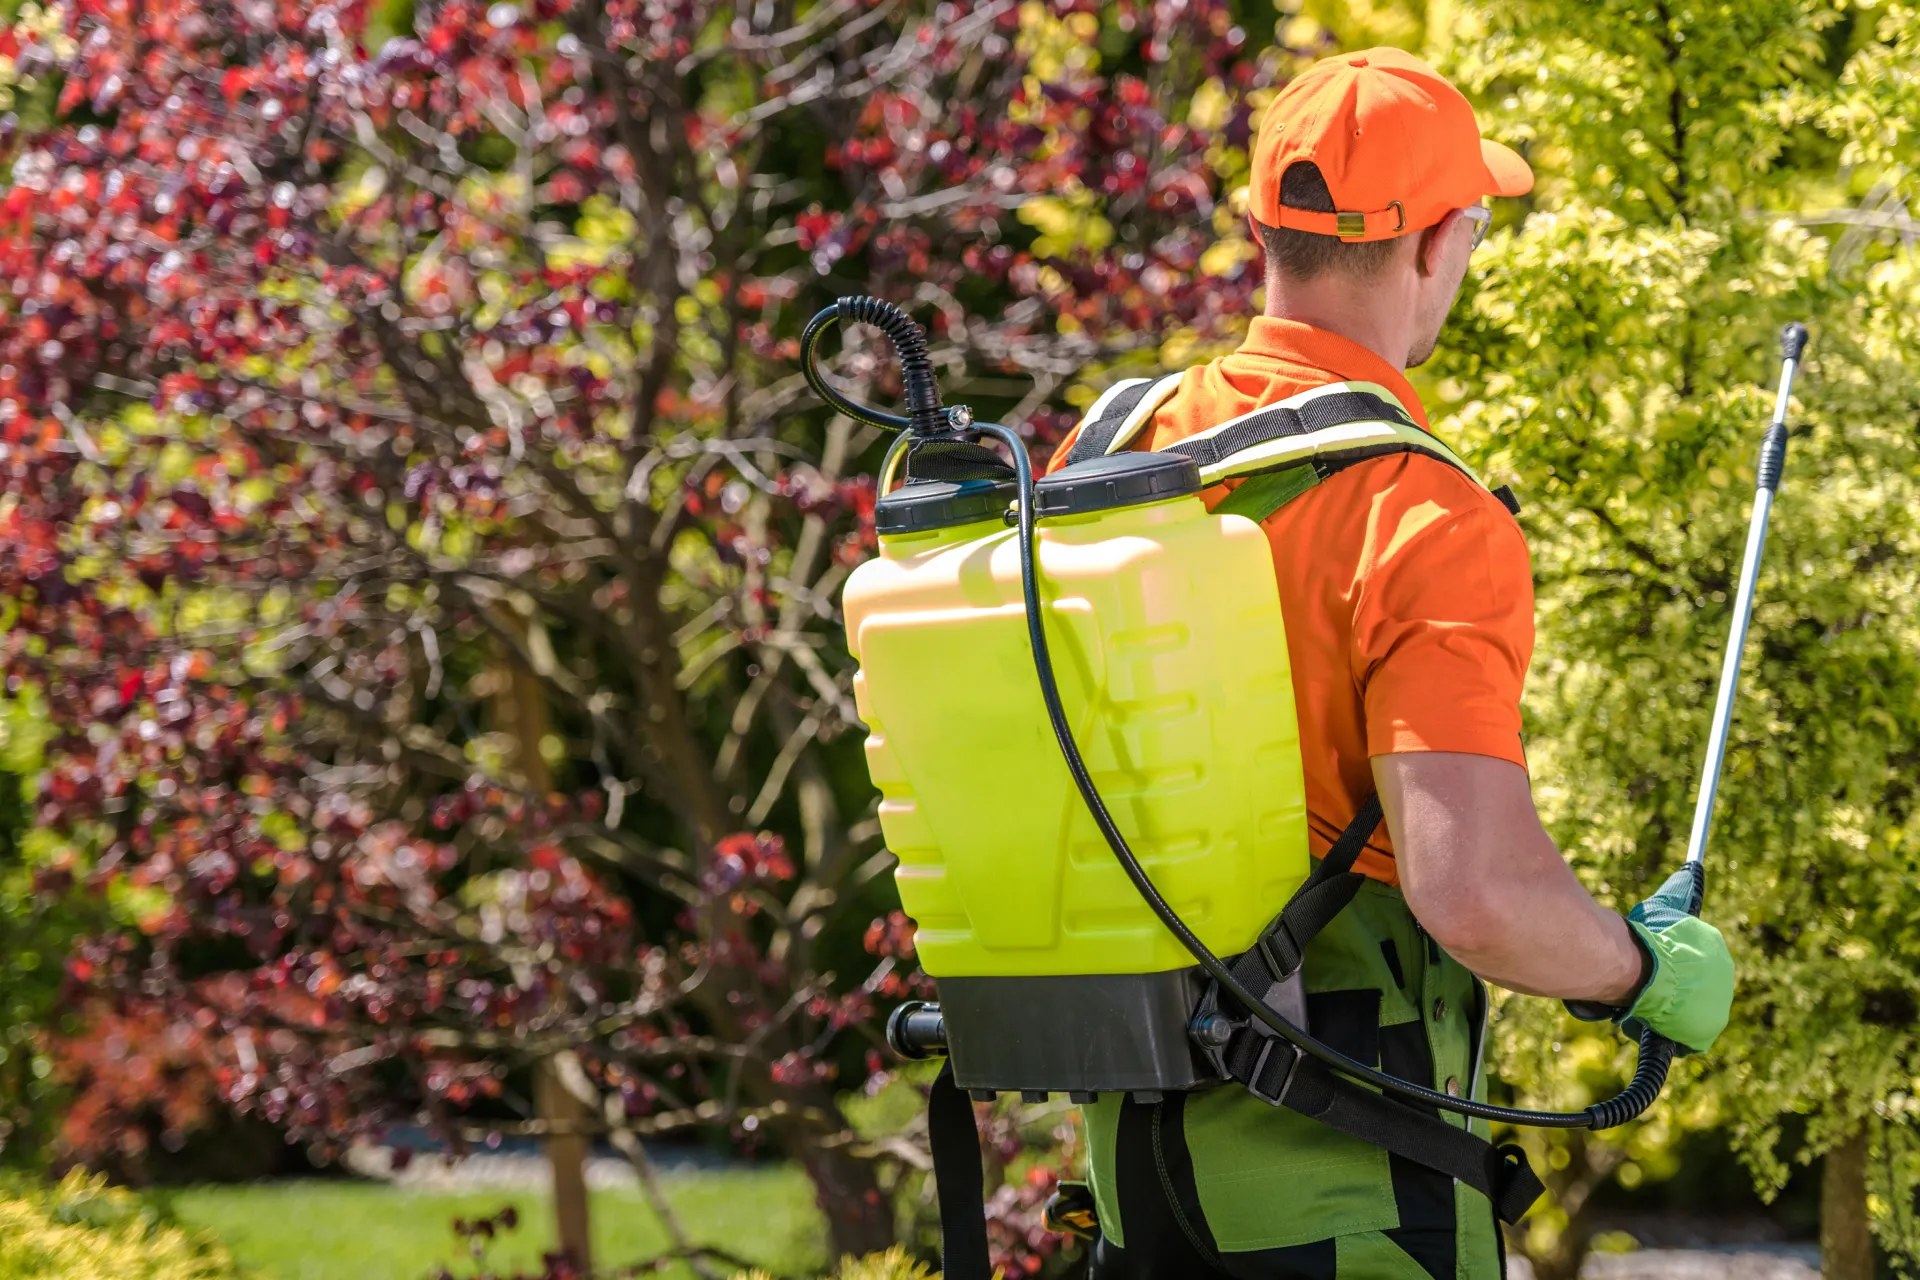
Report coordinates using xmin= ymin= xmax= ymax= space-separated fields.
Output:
xmin=845 ymin=497 xmax=1308 ymax=979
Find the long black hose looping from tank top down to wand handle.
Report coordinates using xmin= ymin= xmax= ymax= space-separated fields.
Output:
xmin=817 ymin=297 xmax=1674 ymax=1128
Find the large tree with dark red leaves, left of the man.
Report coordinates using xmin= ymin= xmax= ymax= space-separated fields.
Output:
xmin=0 ymin=0 xmax=1286 ymax=1259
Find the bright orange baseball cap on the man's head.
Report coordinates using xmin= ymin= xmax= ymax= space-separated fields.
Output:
xmin=1252 ymin=48 xmax=1534 ymax=240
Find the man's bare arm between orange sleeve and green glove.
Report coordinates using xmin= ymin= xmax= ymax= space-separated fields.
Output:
xmin=1373 ymin=750 xmax=1645 ymax=1006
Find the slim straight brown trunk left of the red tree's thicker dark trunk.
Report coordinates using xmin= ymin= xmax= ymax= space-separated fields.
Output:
xmin=493 ymin=640 xmax=593 ymax=1272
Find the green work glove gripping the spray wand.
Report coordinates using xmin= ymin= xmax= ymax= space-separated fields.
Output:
xmin=1567 ymin=869 xmax=1734 ymax=1054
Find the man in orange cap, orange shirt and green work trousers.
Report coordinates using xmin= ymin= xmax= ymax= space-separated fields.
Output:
xmin=1056 ymin=50 xmax=1732 ymax=1280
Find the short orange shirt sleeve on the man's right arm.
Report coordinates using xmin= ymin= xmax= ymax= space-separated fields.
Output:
xmin=1350 ymin=470 xmax=1534 ymax=768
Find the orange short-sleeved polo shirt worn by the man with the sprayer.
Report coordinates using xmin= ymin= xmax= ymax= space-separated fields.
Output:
xmin=1054 ymin=317 xmax=1534 ymax=885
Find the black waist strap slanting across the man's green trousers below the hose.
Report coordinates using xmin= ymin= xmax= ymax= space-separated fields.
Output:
xmin=1225 ymin=1029 xmax=1546 ymax=1224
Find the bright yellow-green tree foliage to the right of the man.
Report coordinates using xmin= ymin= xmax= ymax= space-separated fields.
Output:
xmin=1428 ymin=4 xmax=1920 ymax=1274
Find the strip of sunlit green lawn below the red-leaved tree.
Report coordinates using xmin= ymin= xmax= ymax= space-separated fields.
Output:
xmin=173 ymin=1169 xmax=826 ymax=1280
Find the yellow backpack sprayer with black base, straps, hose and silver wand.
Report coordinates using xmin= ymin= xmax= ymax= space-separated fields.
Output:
xmin=801 ymin=297 xmax=1807 ymax=1278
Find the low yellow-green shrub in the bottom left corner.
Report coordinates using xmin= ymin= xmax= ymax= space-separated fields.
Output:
xmin=0 ymin=1171 xmax=236 ymax=1280
